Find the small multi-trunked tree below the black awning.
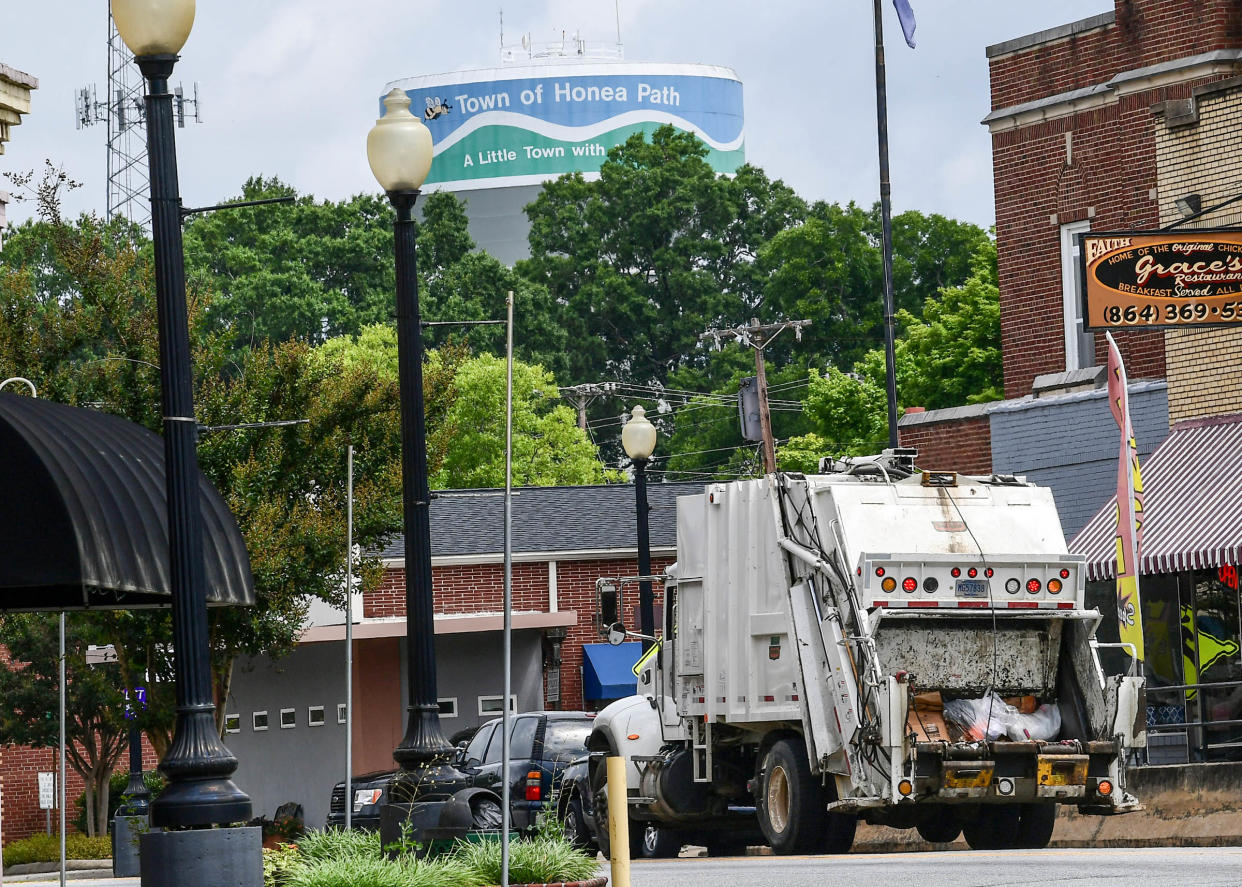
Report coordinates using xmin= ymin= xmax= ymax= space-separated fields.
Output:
xmin=0 ymin=612 xmax=129 ymax=835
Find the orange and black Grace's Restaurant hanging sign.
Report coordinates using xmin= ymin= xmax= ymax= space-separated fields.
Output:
xmin=1079 ymin=230 xmax=1242 ymax=329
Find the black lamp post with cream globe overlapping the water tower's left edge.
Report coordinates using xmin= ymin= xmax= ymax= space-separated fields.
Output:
xmin=366 ymin=89 xmax=466 ymax=800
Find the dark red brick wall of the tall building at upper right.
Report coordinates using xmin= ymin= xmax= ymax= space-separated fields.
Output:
xmin=989 ymin=0 xmax=1242 ymax=398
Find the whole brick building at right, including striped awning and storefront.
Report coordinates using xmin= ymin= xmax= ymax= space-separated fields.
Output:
xmin=900 ymin=0 xmax=1242 ymax=763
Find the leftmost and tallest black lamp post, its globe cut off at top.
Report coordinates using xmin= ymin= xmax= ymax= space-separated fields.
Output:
xmin=112 ymin=0 xmax=251 ymax=827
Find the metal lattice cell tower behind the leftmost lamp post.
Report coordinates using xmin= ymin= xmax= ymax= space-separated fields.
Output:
xmin=76 ymin=7 xmax=202 ymax=229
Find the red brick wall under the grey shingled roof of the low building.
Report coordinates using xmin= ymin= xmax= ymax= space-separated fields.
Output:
xmin=375 ymin=557 xmax=673 ymax=709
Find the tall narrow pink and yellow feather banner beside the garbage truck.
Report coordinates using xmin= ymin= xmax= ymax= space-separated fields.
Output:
xmin=1104 ymin=332 xmax=1144 ymax=662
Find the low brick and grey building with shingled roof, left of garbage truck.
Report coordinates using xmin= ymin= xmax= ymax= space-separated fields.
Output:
xmin=226 ymin=483 xmax=702 ymax=826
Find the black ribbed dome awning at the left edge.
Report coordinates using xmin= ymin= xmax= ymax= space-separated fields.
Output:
xmin=0 ymin=394 xmax=255 ymax=610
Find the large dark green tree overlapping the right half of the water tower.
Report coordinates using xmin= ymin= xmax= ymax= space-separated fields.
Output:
xmin=518 ymin=127 xmax=805 ymax=387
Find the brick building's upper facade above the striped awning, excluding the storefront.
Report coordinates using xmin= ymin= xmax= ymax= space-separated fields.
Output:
xmin=900 ymin=0 xmax=1242 ymax=535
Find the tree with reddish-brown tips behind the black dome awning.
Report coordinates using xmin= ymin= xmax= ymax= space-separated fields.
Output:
xmin=0 ymin=191 xmax=455 ymax=754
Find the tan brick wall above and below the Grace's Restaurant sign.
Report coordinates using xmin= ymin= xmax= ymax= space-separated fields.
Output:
xmin=1155 ymin=78 xmax=1242 ymax=424
